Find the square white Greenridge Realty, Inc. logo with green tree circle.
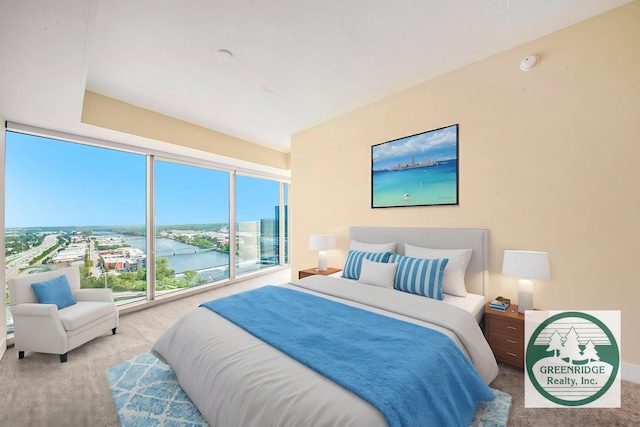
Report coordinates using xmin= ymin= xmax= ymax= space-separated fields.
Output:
xmin=524 ymin=310 xmax=620 ymax=408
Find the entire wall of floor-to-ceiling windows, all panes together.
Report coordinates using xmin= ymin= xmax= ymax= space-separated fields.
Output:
xmin=4 ymin=131 xmax=288 ymax=333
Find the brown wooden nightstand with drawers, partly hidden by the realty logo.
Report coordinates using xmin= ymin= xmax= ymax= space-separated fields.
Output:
xmin=484 ymin=302 xmax=524 ymax=368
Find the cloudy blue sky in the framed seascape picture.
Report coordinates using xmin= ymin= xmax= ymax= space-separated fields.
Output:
xmin=371 ymin=125 xmax=458 ymax=169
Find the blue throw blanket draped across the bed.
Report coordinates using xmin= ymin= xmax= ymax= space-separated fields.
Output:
xmin=202 ymin=286 xmax=494 ymax=427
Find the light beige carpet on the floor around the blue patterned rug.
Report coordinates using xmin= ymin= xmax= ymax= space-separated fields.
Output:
xmin=0 ymin=270 xmax=640 ymax=427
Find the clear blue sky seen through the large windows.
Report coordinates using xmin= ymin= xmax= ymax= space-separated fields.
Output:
xmin=5 ymin=132 xmax=279 ymax=228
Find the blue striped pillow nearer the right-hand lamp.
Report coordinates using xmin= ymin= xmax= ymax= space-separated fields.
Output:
xmin=391 ymin=254 xmax=449 ymax=300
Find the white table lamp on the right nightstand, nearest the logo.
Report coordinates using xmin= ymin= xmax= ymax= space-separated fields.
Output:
xmin=502 ymin=250 xmax=551 ymax=313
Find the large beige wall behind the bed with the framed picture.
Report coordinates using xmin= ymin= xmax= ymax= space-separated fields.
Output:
xmin=291 ymin=2 xmax=640 ymax=365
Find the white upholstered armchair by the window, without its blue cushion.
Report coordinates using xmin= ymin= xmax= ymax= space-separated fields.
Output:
xmin=8 ymin=267 xmax=119 ymax=362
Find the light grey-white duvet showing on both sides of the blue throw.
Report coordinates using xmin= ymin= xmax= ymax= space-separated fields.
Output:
xmin=152 ymin=276 xmax=498 ymax=427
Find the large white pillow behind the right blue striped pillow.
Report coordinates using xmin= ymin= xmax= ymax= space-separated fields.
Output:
xmin=404 ymin=243 xmax=472 ymax=297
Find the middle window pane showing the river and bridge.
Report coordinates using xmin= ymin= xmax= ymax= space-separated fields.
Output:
xmin=155 ymin=161 xmax=230 ymax=294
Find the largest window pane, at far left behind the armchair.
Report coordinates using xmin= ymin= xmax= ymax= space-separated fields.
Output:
xmin=5 ymin=132 xmax=146 ymax=334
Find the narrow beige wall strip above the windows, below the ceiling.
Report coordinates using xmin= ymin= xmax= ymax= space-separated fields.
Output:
xmin=82 ymin=91 xmax=289 ymax=170
